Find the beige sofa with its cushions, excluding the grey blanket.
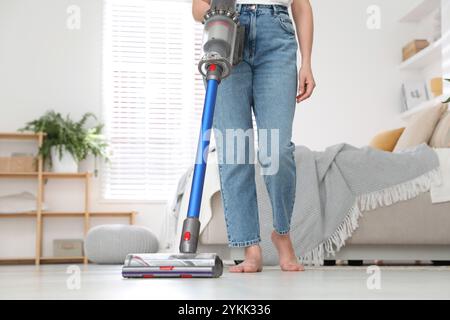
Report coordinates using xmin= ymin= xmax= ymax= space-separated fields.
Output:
xmin=191 ymin=106 xmax=450 ymax=264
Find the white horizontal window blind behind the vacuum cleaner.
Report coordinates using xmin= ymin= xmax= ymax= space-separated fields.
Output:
xmin=102 ymin=0 xmax=204 ymax=200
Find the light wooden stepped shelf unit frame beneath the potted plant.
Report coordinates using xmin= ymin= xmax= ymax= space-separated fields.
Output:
xmin=0 ymin=132 xmax=136 ymax=265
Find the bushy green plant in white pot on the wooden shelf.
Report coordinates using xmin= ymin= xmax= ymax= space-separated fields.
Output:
xmin=19 ymin=111 xmax=108 ymax=173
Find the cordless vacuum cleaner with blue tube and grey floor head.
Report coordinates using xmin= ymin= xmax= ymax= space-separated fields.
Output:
xmin=122 ymin=0 xmax=244 ymax=278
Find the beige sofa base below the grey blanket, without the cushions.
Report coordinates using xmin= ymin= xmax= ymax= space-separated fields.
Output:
xmin=200 ymin=192 xmax=450 ymax=264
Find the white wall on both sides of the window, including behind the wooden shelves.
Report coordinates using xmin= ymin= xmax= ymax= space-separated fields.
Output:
xmin=0 ymin=0 xmax=411 ymax=257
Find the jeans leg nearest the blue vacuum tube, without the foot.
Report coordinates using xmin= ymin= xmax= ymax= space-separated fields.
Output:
xmin=214 ymin=61 xmax=260 ymax=247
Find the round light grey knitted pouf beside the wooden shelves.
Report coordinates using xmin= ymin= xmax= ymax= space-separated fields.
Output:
xmin=84 ymin=224 xmax=158 ymax=264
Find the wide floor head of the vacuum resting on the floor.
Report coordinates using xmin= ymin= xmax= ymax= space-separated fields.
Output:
xmin=122 ymin=253 xmax=223 ymax=278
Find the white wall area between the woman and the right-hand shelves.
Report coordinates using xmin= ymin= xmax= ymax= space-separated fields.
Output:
xmin=294 ymin=0 xmax=414 ymax=149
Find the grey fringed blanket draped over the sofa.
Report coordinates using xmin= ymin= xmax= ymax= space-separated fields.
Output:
xmin=256 ymin=144 xmax=439 ymax=265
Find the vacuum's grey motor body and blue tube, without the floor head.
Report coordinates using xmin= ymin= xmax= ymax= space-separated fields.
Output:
xmin=180 ymin=0 xmax=244 ymax=253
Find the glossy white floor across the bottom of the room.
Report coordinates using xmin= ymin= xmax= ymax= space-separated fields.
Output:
xmin=0 ymin=265 xmax=450 ymax=299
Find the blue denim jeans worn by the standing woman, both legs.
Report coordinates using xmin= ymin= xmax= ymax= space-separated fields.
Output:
xmin=214 ymin=5 xmax=298 ymax=247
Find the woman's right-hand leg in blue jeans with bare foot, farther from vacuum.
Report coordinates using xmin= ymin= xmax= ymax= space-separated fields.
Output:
xmin=253 ymin=5 xmax=303 ymax=271
